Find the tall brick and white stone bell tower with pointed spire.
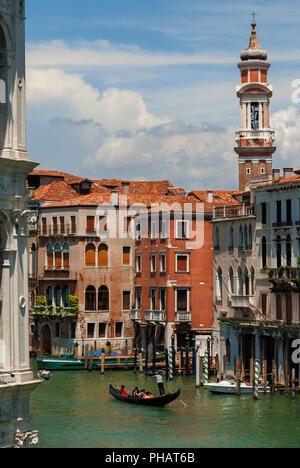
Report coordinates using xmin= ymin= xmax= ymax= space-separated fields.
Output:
xmin=235 ymin=21 xmax=276 ymax=190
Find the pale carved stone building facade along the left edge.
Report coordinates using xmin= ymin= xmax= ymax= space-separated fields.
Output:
xmin=0 ymin=0 xmax=39 ymax=448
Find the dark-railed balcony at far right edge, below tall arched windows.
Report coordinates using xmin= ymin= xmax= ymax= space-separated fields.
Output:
xmin=266 ymin=267 xmax=300 ymax=292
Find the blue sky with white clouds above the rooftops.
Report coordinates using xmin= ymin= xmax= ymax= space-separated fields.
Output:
xmin=26 ymin=0 xmax=300 ymax=190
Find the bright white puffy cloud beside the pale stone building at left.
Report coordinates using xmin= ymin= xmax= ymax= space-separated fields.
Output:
xmin=27 ymin=68 xmax=168 ymax=132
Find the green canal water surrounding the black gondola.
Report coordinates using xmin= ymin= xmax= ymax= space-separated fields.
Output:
xmin=31 ymin=362 xmax=300 ymax=448
